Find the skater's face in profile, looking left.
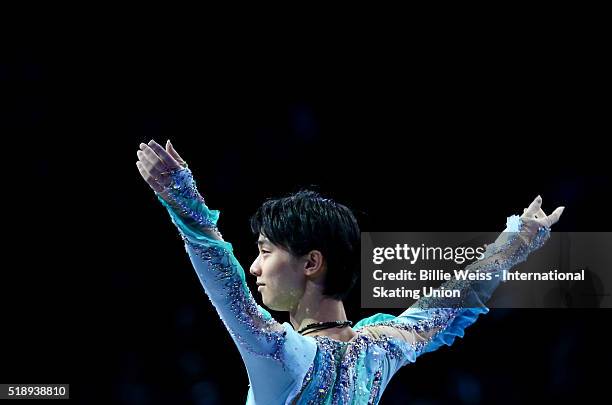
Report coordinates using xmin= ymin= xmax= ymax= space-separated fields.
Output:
xmin=250 ymin=234 xmax=306 ymax=311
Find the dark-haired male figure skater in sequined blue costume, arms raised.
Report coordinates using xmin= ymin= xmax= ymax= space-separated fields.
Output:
xmin=136 ymin=140 xmax=563 ymax=405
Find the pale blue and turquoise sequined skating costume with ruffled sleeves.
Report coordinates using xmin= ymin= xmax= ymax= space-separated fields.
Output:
xmin=158 ymin=168 xmax=550 ymax=405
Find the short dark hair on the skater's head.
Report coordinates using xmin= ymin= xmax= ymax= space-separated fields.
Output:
xmin=251 ymin=190 xmax=361 ymax=300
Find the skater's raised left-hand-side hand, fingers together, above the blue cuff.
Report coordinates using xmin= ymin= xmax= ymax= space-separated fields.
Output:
xmin=136 ymin=139 xmax=187 ymax=197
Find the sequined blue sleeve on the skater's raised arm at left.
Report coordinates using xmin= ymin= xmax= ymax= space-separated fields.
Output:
xmin=158 ymin=167 xmax=316 ymax=403
